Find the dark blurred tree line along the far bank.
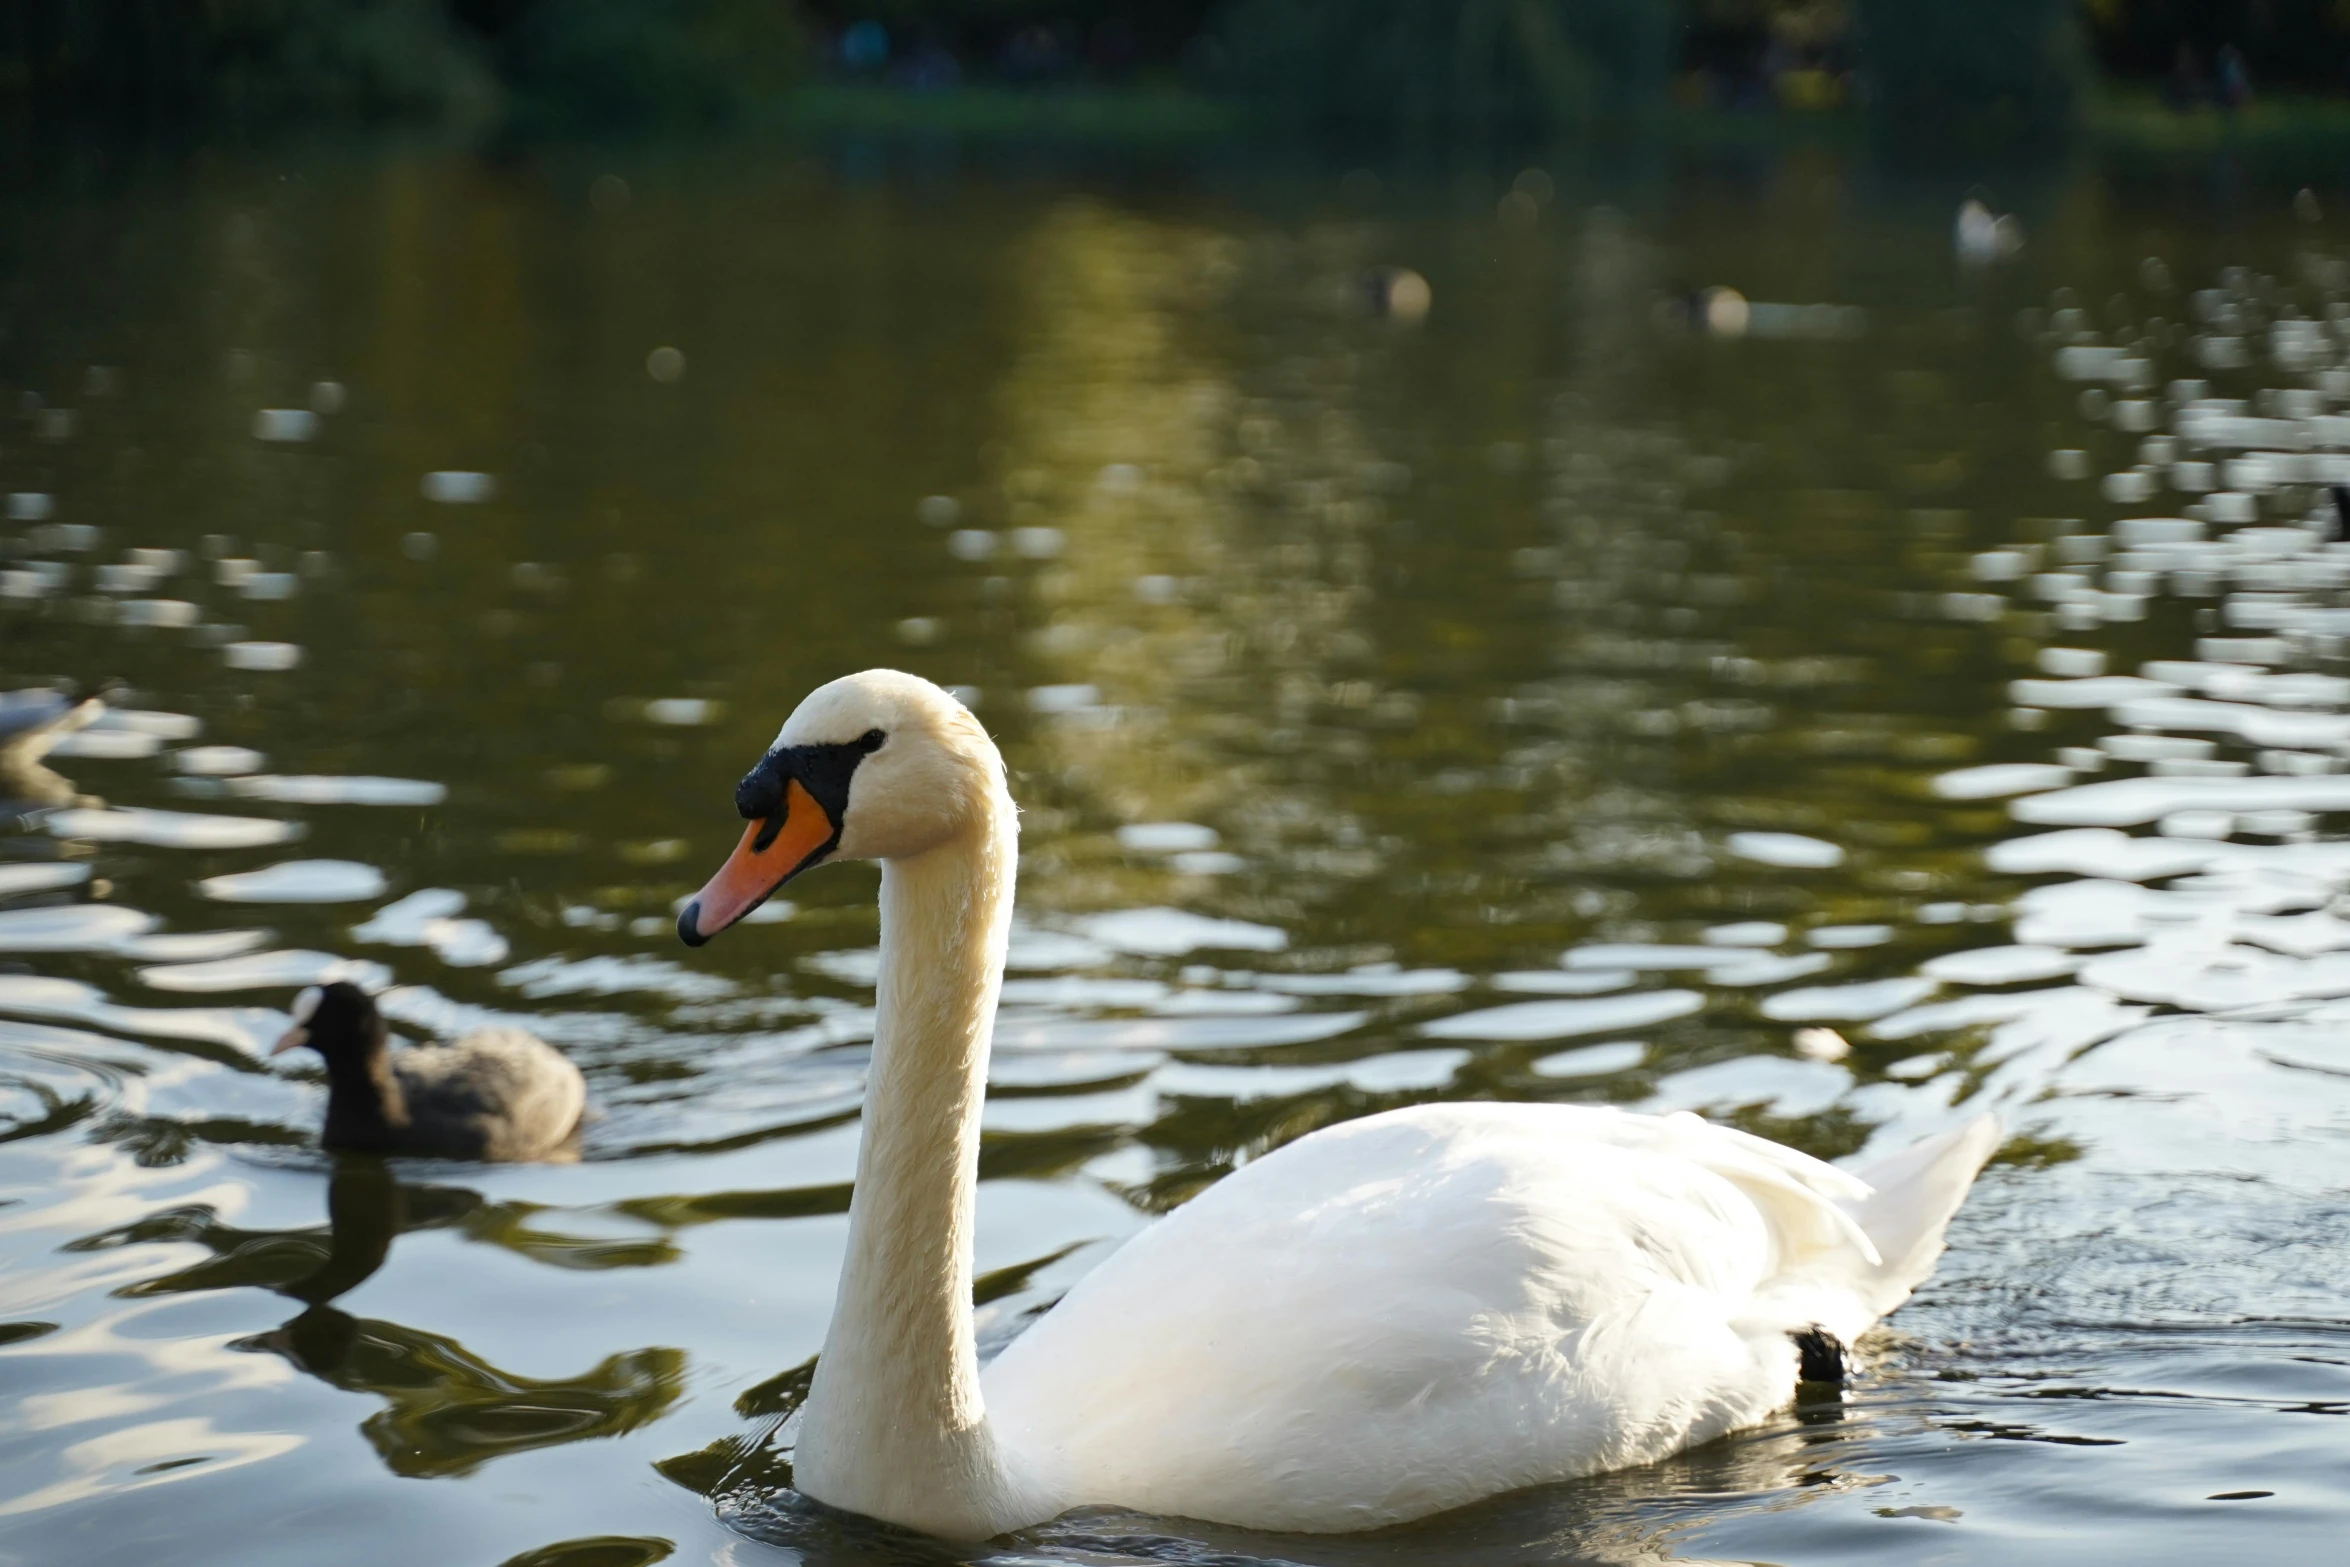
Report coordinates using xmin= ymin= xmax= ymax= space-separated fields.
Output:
xmin=0 ymin=0 xmax=2350 ymax=136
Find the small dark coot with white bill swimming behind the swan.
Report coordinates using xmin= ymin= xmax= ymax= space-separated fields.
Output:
xmin=270 ymin=980 xmax=588 ymax=1161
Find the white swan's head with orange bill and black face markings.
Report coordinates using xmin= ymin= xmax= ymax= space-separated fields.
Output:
xmin=677 ymin=670 xmax=1003 ymax=947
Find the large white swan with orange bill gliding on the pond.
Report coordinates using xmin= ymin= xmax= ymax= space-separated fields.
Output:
xmin=677 ymin=670 xmax=1995 ymax=1539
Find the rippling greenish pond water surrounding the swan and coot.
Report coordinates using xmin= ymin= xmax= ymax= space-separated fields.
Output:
xmin=0 ymin=148 xmax=2350 ymax=1567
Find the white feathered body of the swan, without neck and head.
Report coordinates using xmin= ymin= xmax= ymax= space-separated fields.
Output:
xmin=985 ymin=1104 xmax=1981 ymax=1532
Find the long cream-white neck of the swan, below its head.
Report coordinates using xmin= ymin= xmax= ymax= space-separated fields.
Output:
xmin=794 ymin=792 xmax=1022 ymax=1539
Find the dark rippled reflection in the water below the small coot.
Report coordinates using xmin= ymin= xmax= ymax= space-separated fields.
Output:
xmin=242 ymin=1156 xmax=686 ymax=1475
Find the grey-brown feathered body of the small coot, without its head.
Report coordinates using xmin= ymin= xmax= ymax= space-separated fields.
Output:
xmin=392 ymin=1029 xmax=588 ymax=1161
